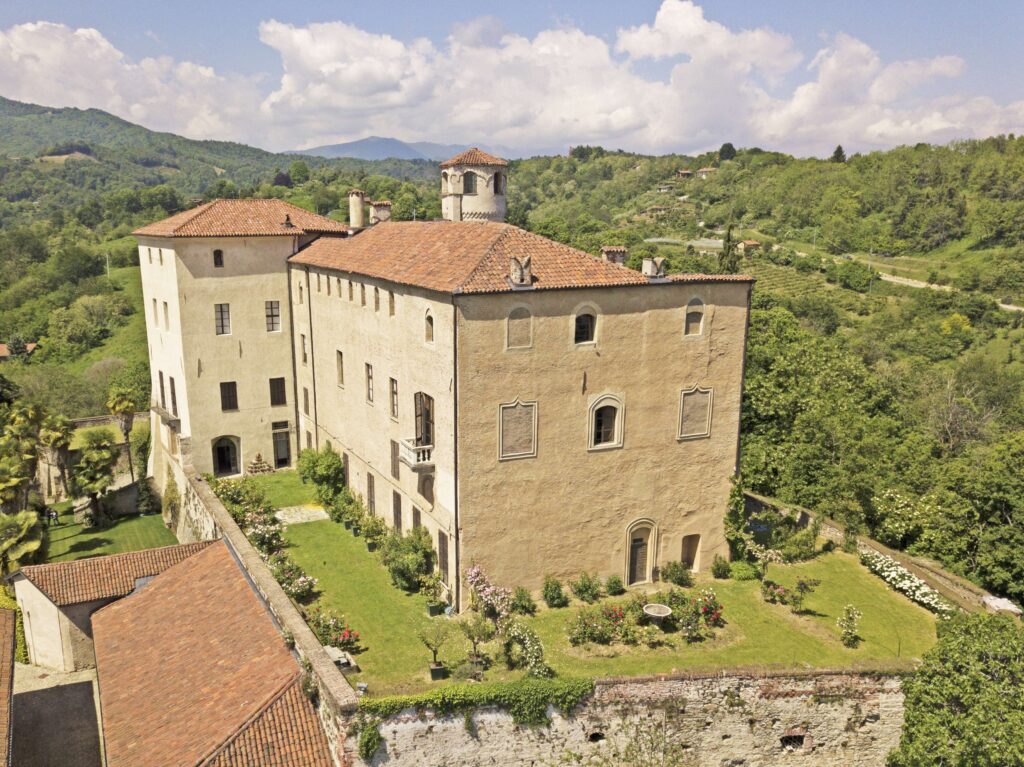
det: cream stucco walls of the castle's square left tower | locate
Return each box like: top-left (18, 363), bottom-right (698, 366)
top-left (139, 237), bottom-right (311, 482)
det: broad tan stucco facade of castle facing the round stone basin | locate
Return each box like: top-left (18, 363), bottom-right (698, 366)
top-left (458, 283), bottom-right (749, 589)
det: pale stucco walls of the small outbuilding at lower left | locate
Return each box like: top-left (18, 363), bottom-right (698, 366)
top-left (12, 574), bottom-right (114, 671)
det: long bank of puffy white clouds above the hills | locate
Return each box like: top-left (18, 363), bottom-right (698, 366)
top-left (0, 5), bottom-right (1024, 155)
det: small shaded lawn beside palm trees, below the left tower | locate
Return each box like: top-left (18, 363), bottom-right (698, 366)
top-left (47, 511), bottom-right (177, 562)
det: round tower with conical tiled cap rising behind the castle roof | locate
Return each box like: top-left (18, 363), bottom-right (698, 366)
top-left (441, 146), bottom-right (508, 221)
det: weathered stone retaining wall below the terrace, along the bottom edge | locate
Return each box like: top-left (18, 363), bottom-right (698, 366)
top-left (347, 672), bottom-right (903, 767)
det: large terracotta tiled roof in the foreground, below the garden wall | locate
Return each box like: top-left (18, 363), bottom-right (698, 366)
top-left (92, 541), bottom-right (332, 767)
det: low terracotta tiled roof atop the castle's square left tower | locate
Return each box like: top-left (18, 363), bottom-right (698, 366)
top-left (132, 200), bottom-right (348, 237)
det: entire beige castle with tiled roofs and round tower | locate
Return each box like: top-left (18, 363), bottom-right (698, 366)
top-left (136, 150), bottom-right (752, 604)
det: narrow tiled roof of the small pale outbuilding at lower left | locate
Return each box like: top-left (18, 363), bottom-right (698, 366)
top-left (22, 541), bottom-right (210, 605)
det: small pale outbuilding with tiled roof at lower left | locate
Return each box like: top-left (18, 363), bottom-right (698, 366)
top-left (10, 541), bottom-right (210, 671)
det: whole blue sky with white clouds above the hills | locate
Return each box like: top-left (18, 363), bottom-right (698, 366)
top-left (0, 0), bottom-right (1024, 154)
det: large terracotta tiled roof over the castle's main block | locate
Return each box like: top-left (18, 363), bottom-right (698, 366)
top-left (291, 221), bottom-right (750, 294)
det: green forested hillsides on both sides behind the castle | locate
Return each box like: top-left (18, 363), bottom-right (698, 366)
top-left (0, 102), bottom-right (1024, 601)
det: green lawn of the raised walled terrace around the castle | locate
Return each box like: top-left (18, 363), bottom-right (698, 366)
top-left (286, 521), bottom-right (935, 694)
